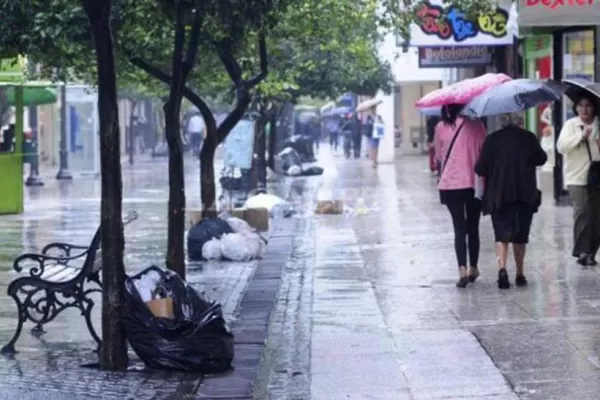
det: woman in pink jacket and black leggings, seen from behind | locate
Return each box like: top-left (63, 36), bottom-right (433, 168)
top-left (434, 104), bottom-right (486, 288)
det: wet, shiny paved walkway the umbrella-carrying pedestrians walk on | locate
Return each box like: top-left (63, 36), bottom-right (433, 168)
top-left (255, 147), bottom-right (600, 400)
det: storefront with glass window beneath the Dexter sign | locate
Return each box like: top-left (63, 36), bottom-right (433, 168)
top-left (519, 0), bottom-right (600, 202)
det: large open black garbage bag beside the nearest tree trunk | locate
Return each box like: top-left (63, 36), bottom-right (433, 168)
top-left (125, 266), bottom-right (234, 373)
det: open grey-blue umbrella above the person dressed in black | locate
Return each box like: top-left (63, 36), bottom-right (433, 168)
top-left (461, 79), bottom-right (565, 117)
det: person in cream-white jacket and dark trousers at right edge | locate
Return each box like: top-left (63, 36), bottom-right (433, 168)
top-left (556, 94), bottom-right (600, 266)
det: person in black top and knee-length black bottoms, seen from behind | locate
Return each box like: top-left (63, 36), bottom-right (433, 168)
top-left (475, 116), bottom-right (548, 289)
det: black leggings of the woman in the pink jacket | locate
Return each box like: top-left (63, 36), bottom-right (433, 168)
top-left (444, 189), bottom-right (481, 267)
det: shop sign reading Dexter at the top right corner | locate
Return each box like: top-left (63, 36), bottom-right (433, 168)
top-left (519, 0), bottom-right (600, 27)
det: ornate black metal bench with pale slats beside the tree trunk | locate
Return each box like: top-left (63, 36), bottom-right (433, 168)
top-left (1, 211), bottom-right (138, 354)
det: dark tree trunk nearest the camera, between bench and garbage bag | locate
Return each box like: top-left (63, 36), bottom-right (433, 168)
top-left (83, 0), bottom-right (128, 371)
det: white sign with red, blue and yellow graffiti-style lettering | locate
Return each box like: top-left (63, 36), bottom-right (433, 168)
top-left (410, 0), bottom-right (513, 47)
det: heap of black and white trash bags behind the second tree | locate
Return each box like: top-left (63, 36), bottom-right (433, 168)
top-left (187, 213), bottom-right (267, 261)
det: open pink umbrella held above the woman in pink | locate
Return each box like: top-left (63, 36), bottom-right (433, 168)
top-left (415, 73), bottom-right (512, 108)
